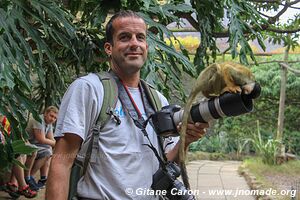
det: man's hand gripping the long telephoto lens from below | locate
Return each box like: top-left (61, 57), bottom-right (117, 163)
top-left (177, 122), bottom-right (209, 148)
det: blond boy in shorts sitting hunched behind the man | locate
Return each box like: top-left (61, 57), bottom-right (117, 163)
top-left (25, 106), bottom-right (58, 190)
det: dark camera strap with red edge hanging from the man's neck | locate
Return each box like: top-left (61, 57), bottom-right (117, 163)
top-left (113, 74), bottom-right (167, 168)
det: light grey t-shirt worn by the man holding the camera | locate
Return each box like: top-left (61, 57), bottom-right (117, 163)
top-left (55, 74), bottom-right (178, 200)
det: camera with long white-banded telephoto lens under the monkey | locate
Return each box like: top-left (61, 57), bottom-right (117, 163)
top-left (152, 83), bottom-right (261, 136)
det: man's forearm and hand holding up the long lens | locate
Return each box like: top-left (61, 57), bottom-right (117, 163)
top-left (166, 122), bottom-right (209, 162)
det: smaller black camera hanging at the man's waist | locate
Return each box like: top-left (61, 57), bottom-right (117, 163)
top-left (151, 162), bottom-right (196, 200)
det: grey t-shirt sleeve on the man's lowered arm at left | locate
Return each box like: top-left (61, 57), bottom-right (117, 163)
top-left (55, 74), bottom-right (103, 140)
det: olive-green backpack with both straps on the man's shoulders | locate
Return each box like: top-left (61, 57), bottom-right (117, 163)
top-left (68, 72), bottom-right (162, 200)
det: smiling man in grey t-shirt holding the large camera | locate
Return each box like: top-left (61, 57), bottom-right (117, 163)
top-left (46, 11), bottom-right (208, 200)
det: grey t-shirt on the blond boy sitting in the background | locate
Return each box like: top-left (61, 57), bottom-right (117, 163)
top-left (26, 114), bottom-right (53, 147)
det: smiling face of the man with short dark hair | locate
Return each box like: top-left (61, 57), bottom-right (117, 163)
top-left (104, 17), bottom-right (148, 74)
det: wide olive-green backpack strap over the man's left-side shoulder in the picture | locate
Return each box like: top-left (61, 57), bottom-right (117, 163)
top-left (83, 72), bottom-right (118, 175)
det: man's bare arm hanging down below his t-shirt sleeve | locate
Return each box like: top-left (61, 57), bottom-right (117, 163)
top-left (46, 133), bottom-right (82, 200)
